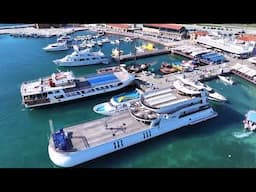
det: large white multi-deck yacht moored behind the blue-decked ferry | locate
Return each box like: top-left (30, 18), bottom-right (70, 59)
top-left (53, 45), bottom-right (110, 66)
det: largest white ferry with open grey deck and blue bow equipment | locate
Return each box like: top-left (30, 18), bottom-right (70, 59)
top-left (48, 88), bottom-right (217, 167)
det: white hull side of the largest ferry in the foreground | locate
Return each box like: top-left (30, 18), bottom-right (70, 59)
top-left (48, 108), bottom-right (217, 167)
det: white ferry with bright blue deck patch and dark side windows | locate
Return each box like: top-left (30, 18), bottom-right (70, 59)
top-left (20, 68), bottom-right (135, 108)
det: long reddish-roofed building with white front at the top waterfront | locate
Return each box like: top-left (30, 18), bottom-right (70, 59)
top-left (143, 24), bottom-right (188, 40)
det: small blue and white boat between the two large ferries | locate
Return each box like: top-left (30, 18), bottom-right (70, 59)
top-left (93, 89), bottom-right (142, 115)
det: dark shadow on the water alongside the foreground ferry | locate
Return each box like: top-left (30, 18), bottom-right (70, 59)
top-left (77, 103), bottom-right (243, 168)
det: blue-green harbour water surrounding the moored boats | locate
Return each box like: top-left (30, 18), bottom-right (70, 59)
top-left (0, 29), bottom-right (256, 168)
